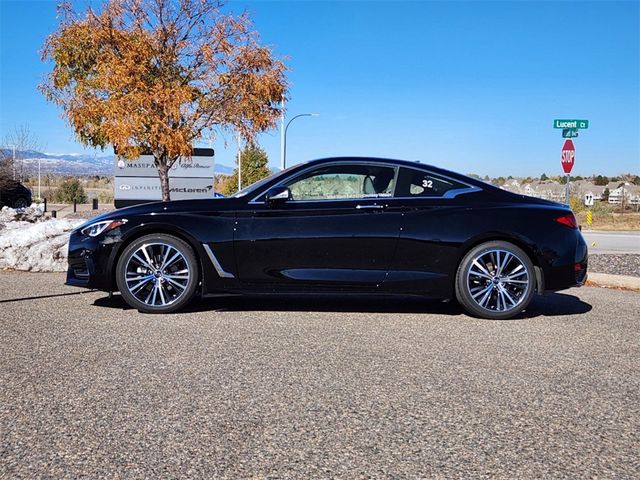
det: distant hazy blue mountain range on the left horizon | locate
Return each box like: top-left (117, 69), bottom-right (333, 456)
top-left (0, 149), bottom-right (233, 175)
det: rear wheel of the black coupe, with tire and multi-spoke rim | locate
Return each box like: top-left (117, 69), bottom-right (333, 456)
top-left (455, 240), bottom-right (536, 320)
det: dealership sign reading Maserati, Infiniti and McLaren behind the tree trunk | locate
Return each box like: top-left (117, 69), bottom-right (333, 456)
top-left (114, 148), bottom-right (213, 208)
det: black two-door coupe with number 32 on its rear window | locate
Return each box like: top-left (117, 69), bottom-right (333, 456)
top-left (67, 158), bottom-right (587, 319)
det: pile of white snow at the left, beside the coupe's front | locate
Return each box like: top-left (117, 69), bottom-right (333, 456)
top-left (0, 207), bottom-right (84, 272)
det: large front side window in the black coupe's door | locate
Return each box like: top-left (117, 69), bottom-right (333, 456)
top-left (287, 165), bottom-right (395, 201)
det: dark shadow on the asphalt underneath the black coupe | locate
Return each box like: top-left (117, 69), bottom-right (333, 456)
top-left (94, 293), bottom-right (592, 320)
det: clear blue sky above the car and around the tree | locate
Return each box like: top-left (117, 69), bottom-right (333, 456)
top-left (0, 0), bottom-right (640, 177)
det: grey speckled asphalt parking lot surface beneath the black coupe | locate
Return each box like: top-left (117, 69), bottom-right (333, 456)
top-left (0, 272), bottom-right (640, 479)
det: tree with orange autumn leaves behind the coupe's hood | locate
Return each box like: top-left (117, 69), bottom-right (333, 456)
top-left (40, 0), bottom-right (287, 201)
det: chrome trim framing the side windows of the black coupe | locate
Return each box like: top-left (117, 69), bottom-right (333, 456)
top-left (248, 161), bottom-right (482, 205)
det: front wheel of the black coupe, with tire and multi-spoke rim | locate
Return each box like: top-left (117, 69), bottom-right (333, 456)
top-left (116, 234), bottom-right (199, 313)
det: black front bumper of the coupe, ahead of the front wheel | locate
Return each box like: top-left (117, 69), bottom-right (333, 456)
top-left (65, 229), bottom-right (122, 291)
